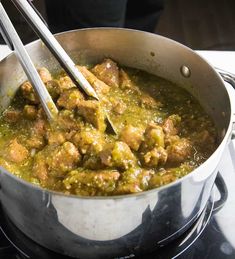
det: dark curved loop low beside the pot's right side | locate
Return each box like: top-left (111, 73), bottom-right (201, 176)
top-left (213, 172), bottom-right (228, 214)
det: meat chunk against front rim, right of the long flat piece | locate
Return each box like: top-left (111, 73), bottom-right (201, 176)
top-left (115, 168), bottom-right (154, 194)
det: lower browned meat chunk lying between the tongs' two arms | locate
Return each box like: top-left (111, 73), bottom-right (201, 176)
top-left (57, 88), bottom-right (84, 110)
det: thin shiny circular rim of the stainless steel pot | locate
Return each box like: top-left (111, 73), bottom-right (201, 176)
top-left (0, 27), bottom-right (234, 200)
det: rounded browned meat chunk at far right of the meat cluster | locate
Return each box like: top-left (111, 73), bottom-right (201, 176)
top-left (167, 138), bottom-right (192, 163)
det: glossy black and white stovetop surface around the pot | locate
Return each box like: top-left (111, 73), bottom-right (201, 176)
top-left (0, 46), bottom-right (235, 259)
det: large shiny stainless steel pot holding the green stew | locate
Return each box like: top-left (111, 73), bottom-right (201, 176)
top-left (0, 28), bottom-right (234, 258)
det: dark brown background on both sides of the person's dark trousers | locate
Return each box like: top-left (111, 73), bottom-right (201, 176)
top-left (2, 0), bottom-right (235, 50)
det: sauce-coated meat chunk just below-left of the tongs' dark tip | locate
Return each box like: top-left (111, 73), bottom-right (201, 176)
top-left (72, 129), bottom-right (104, 154)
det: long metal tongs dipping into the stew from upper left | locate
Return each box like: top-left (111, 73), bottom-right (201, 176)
top-left (0, 0), bottom-right (116, 133)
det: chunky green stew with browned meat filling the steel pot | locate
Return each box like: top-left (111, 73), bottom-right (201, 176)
top-left (0, 59), bottom-right (216, 196)
